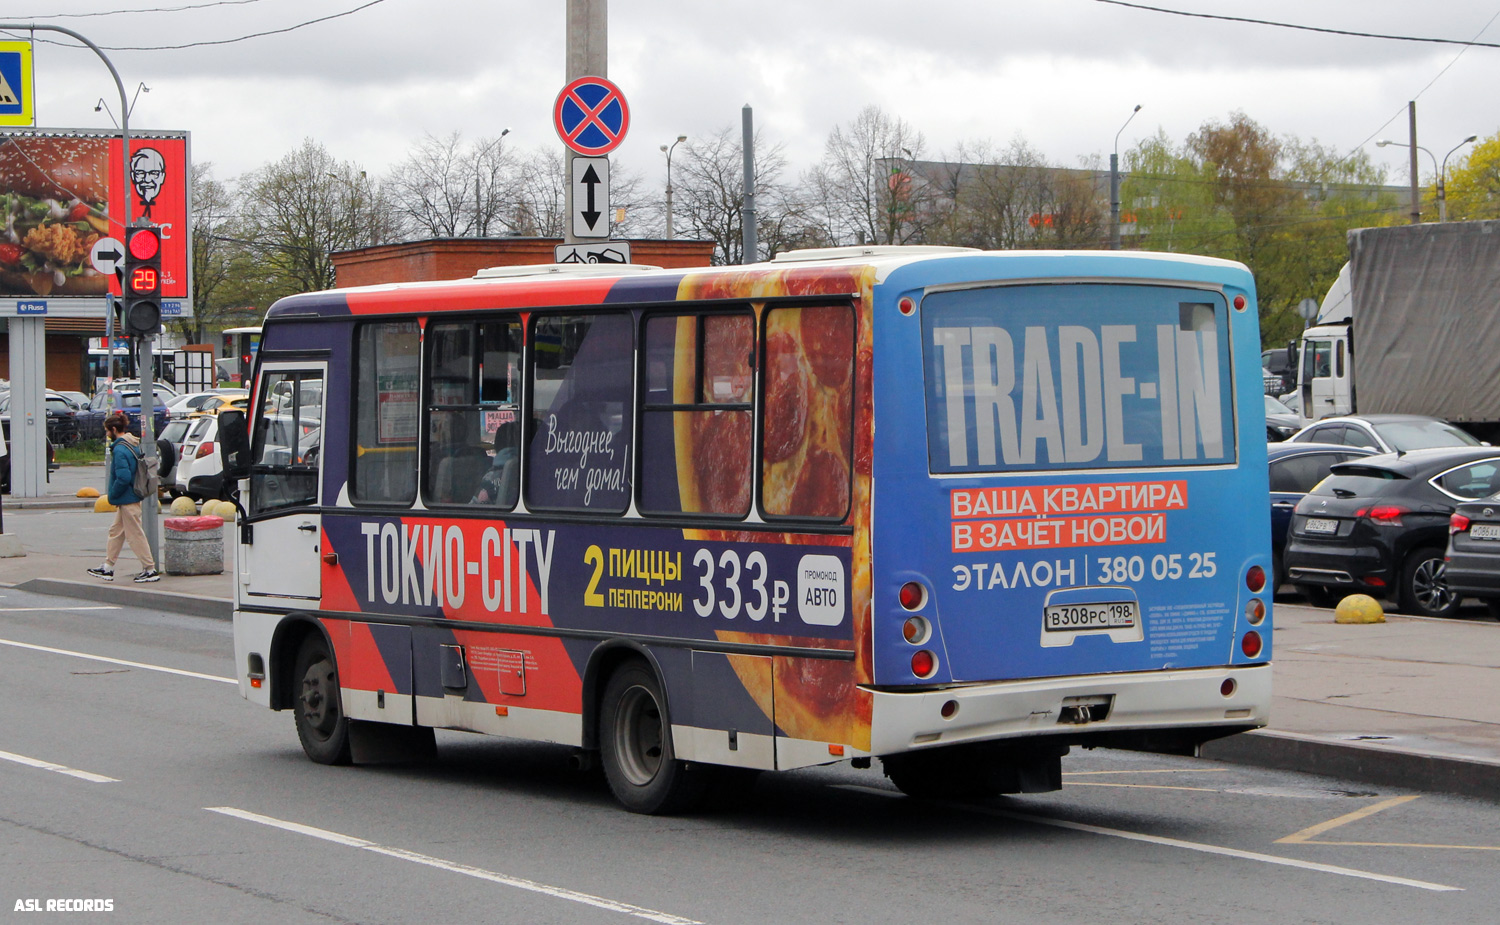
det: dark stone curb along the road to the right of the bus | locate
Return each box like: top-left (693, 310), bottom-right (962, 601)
top-left (1199, 730), bottom-right (1500, 802)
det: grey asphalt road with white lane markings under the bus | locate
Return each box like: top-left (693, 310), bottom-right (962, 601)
top-left (0, 591), bottom-right (1500, 925)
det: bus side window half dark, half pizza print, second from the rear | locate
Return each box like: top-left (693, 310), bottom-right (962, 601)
top-left (639, 312), bottom-right (755, 517)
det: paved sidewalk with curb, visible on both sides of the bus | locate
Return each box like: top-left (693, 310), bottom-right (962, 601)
top-left (0, 466), bottom-right (1500, 799)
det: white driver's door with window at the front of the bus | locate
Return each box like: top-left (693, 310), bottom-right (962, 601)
top-left (240, 363), bottom-right (326, 600)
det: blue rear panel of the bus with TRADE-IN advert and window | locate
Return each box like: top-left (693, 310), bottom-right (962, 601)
top-left (872, 255), bottom-right (1271, 685)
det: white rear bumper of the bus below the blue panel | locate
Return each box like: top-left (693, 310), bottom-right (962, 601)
top-left (870, 664), bottom-right (1271, 754)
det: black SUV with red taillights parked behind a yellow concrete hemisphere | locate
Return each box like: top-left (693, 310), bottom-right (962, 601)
top-left (1284, 447), bottom-right (1500, 616)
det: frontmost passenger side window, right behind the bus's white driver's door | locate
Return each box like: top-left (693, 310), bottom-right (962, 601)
top-left (350, 321), bottom-right (422, 505)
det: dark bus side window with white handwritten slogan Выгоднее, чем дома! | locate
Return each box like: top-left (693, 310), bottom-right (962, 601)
top-left (525, 312), bottom-right (636, 514)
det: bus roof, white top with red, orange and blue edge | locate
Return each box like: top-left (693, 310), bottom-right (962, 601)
top-left (261, 246), bottom-right (1248, 320)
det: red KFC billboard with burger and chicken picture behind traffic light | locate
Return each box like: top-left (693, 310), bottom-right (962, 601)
top-left (0, 130), bottom-right (192, 316)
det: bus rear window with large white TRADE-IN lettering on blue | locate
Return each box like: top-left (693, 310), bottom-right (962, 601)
top-left (923, 283), bottom-right (1235, 472)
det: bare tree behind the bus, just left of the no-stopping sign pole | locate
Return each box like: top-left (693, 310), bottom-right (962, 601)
top-left (386, 132), bottom-right (519, 238)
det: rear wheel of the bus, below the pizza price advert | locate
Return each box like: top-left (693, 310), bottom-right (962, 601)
top-left (599, 661), bottom-right (713, 816)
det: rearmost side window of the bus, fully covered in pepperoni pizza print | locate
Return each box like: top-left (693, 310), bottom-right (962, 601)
top-left (761, 304), bottom-right (855, 519)
